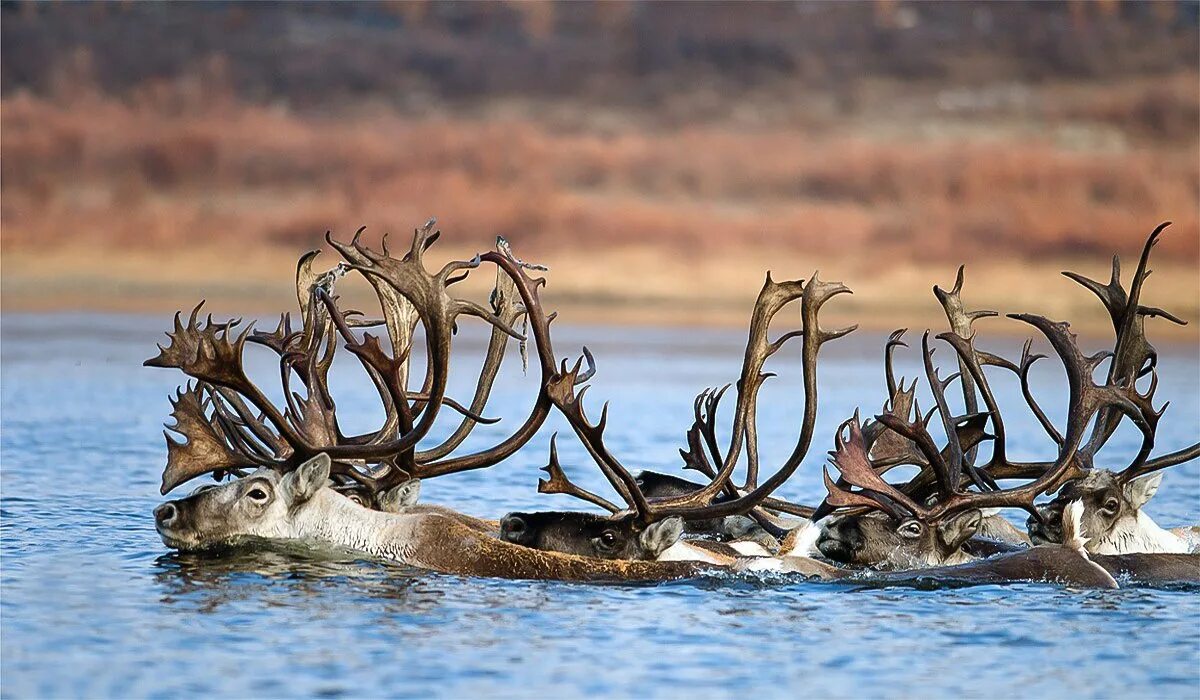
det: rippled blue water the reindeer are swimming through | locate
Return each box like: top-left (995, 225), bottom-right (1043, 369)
top-left (0, 315), bottom-right (1200, 698)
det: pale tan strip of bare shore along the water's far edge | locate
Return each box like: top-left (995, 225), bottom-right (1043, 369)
top-left (0, 240), bottom-right (1200, 342)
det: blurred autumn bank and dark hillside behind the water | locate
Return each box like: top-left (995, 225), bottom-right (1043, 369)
top-left (0, 0), bottom-right (1200, 339)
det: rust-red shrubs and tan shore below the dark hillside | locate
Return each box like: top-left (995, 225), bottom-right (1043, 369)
top-left (0, 1), bottom-right (1200, 336)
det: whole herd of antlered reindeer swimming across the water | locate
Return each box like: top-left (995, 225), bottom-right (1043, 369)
top-left (145, 221), bottom-right (1200, 587)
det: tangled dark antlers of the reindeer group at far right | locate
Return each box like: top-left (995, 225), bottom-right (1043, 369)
top-left (815, 225), bottom-right (1200, 521)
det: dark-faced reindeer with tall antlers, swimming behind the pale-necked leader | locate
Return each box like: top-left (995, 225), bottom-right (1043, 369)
top-left (500, 268), bottom-right (853, 563)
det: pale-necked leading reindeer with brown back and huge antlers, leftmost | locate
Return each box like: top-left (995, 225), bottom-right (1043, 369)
top-left (146, 221), bottom-right (697, 580)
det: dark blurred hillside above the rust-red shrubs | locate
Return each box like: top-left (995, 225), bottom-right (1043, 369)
top-left (0, 0), bottom-right (1200, 108)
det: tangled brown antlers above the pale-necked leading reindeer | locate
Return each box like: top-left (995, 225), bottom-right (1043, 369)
top-left (145, 220), bottom-right (554, 493)
